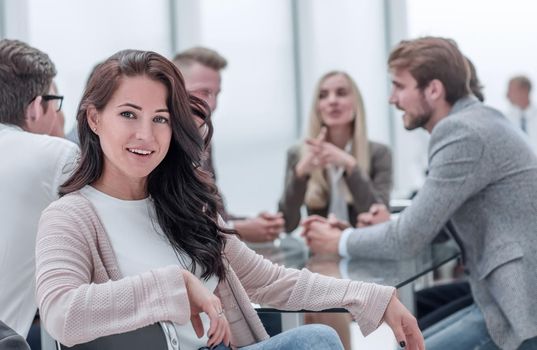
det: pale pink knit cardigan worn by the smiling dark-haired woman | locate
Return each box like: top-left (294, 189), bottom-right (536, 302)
top-left (36, 192), bottom-right (394, 347)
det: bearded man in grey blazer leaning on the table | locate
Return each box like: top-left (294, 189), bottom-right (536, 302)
top-left (304, 37), bottom-right (537, 350)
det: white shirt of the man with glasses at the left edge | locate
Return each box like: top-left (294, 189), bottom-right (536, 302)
top-left (0, 123), bottom-right (78, 337)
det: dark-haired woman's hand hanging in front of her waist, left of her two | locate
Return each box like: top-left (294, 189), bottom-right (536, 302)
top-left (183, 270), bottom-right (231, 347)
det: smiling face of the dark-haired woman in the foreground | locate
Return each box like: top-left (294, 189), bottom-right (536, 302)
top-left (88, 75), bottom-right (172, 183)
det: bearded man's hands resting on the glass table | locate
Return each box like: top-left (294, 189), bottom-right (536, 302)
top-left (301, 204), bottom-right (390, 254)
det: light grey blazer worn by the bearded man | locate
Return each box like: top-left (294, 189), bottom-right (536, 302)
top-left (347, 97), bottom-right (537, 350)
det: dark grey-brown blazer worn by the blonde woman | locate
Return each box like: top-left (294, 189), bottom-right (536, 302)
top-left (278, 141), bottom-right (392, 232)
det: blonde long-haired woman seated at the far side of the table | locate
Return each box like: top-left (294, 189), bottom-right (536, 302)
top-left (279, 71), bottom-right (392, 232)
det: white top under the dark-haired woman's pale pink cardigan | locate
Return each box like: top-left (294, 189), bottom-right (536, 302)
top-left (80, 186), bottom-right (218, 350)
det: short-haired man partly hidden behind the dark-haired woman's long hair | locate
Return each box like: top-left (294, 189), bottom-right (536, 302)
top-left (173, 47), bottom-right (284, 242)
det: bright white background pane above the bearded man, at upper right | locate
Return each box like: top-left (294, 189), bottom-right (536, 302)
top-left (407, 0), bottom-right (537, 117)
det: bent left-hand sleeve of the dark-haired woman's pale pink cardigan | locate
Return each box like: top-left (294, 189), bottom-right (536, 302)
top-left (36, 197), bottom-right (190, 346)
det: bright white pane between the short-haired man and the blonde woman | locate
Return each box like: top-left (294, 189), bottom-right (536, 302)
top-left (185, 0), bottom-right (295, 215)
